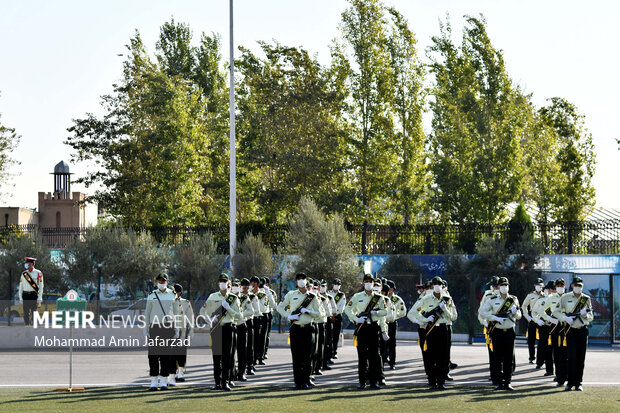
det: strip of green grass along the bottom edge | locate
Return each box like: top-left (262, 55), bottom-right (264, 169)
top-left (0, 386), bottom-right (620, 413)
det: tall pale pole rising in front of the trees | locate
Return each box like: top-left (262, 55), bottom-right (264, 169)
top-left (228, 0), bottom-right (237, 277)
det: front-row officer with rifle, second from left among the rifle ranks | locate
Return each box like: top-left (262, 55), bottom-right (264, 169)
top-left (276, 272), bottom-right (320, 390)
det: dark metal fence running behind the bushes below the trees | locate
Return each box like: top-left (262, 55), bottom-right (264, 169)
top-left (0, 220), bottom-right (620, 254)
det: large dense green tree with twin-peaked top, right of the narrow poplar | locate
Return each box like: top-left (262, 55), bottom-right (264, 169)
top-left (429, 17), bottom-right (527, 229)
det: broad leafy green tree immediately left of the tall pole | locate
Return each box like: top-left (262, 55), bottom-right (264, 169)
top-left (66, 20), bottom-right (227, 225)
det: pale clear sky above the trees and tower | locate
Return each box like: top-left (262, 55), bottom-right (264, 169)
top-left (0, 0), bottom-right (620, 224)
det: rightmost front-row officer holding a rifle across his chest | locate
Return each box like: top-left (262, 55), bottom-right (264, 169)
top-left (553, 277), bottom-right (594, 391)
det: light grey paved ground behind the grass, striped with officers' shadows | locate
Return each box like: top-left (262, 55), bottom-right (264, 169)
top-left (0, 334), bottom-right (620, 387)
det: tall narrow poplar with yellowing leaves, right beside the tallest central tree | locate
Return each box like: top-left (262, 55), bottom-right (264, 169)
top-left (387, 8), bottom-right (429, 225)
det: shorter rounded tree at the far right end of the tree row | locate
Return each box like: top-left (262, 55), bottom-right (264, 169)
top-left (539, 97), bottom-right (596, 222)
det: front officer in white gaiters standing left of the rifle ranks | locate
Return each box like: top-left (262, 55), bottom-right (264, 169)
top-left (144, 273), bottom-right (179, 391)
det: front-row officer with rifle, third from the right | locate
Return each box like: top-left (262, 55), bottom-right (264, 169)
top-left (414, 277), bottom-right (452, 390)
